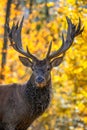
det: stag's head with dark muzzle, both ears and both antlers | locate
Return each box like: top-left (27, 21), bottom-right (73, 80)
top-left (7, 17), bottom-right (83, 87)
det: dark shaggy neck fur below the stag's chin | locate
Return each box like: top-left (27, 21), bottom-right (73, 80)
top-left (25, 75), bottom-right (51, 117)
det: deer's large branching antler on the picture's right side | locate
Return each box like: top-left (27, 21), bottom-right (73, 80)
top-left (47, 17), bottom-right (84, 59)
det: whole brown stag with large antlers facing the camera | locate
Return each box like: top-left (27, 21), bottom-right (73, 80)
top-left (0, 17), bottom-right (83, 130)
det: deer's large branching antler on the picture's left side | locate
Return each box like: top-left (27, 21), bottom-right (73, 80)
top-left (7, 17), bottom-right (36, 60)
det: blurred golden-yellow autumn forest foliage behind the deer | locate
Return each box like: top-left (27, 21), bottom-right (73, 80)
top-left (0, 0), bottom-right (87, 130)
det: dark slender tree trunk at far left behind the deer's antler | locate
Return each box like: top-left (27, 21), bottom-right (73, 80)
top-left (0, 0), bottom-right (12, 79)
